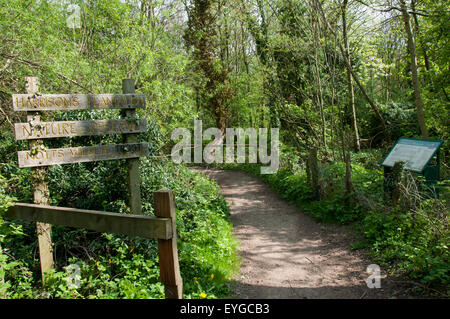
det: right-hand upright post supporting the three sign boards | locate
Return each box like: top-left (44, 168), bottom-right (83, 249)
top-left (122, 79), bottom-right (142, 215)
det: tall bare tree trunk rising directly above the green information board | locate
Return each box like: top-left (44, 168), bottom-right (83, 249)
top-left (399, 0), bottom-right (428, 138)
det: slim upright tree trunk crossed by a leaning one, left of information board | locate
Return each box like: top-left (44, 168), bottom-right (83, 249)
top-left (342, 0), bottom-right (361, 152)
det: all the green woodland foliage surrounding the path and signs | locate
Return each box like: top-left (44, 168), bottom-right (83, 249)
top-left (0, 0), bottom-right (450, 298)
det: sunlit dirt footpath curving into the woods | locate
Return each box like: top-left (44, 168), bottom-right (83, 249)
top-left (195, 168), bottom-right (411, 299)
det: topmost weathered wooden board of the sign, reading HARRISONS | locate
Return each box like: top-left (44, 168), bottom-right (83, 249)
top-left (13, 94), bottom-right (145, 111)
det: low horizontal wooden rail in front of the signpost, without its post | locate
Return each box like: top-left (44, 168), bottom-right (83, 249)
top-left (3, 203), bottom-right (173, 240)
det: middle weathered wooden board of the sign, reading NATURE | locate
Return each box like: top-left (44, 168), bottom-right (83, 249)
top-left (14, 120), bottom-right (147, 140)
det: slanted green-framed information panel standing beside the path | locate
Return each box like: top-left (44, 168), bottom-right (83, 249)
top-left (381, 137), bottom-right (444, 173)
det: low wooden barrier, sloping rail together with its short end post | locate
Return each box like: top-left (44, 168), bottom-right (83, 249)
top-left (3, 190), bottom-right (183, 299)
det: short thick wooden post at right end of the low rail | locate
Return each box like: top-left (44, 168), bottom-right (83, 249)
top-left (154, 190), bottom-right (183, 299)
